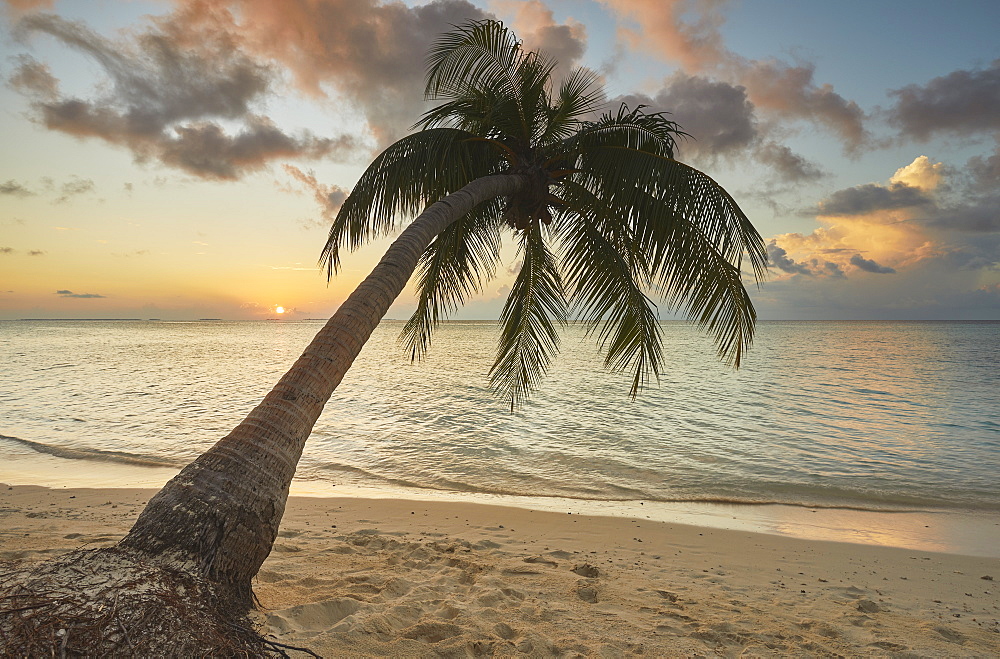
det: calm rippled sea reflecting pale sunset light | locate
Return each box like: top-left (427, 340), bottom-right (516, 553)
top-left (0, 321), bottom-right (1000, 512)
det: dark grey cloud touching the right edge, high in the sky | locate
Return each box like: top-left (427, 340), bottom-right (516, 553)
top-left (888, 59), bottom-right (1000, 140)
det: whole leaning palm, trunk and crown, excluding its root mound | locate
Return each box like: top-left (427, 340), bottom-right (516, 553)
top-left (3, 21), bottom-right (765, 652)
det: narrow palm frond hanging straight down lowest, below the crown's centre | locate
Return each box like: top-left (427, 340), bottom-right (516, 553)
top-left (490, 224), bottom-right (566, 411)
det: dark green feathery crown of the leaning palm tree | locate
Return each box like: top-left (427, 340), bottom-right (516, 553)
top-left (321, 21), bottom-right (766, 408)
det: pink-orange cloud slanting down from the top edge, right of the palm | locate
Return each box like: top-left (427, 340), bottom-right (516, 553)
top-left (601, 0), bottom-right (870, 153)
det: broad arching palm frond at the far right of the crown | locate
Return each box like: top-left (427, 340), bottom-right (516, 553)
top-left (560, 146), bottom-right (766, 366)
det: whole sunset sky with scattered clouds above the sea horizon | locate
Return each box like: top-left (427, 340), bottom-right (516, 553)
top-left (0, 0), bottom-right (1000, 320)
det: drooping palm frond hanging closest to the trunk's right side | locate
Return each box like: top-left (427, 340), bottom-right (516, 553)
top-left (400, 200), bottom-right (500, 360)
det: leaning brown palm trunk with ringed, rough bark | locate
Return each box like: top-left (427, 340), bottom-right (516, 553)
top-left (119, 174), bottom-right (528, 606)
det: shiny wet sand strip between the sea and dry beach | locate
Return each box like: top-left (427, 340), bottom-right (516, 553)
top-left (0, 454), bottom-right (1000, 558)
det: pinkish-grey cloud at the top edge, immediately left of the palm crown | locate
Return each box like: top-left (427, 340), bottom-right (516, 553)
top-left (214, 0), bottom-right (488, 146)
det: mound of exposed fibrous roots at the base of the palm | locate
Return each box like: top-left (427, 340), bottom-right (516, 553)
top-left (0, 548), bottom-right (315, 657)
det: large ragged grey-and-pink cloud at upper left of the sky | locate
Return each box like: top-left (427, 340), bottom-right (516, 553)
top-left (11, 10), bottom-right (355, 180)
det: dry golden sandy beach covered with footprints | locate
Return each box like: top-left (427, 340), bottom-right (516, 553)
top-left (0, 485), bottom-right (1000, 657)
